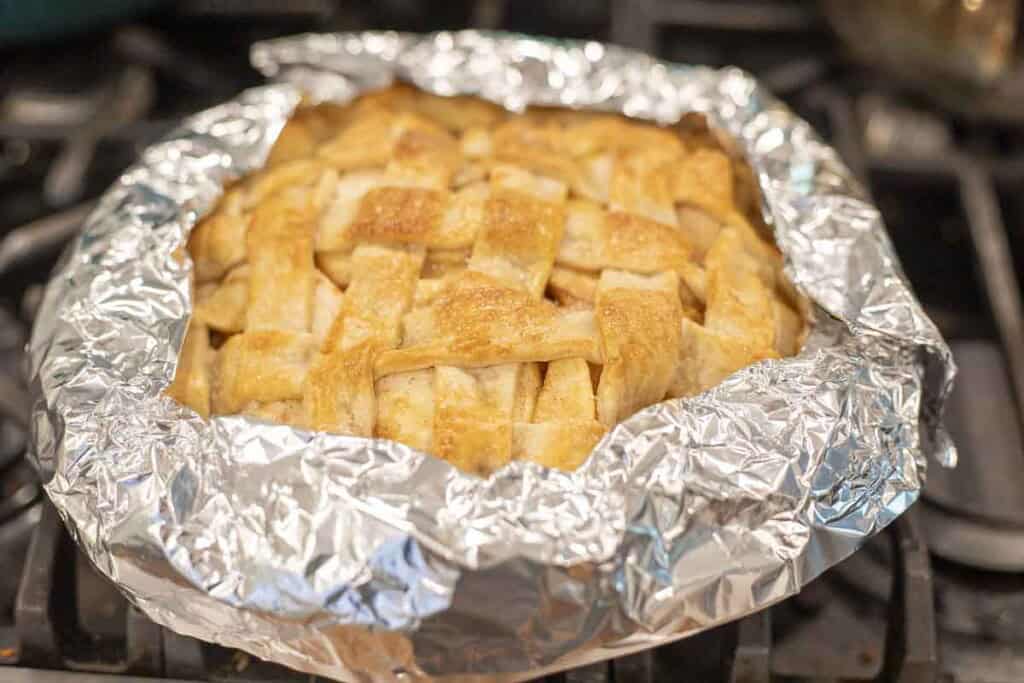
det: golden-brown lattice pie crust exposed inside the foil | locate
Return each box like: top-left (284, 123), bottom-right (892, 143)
top-left (168, 86), bottom-right (805, 474)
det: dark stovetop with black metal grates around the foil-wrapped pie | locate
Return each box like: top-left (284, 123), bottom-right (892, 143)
top-left (0, 0), bottom-right (1024, 683)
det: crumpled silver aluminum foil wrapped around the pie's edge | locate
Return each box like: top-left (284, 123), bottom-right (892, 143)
top-left (30, 32), bottom-right (955, 681)
